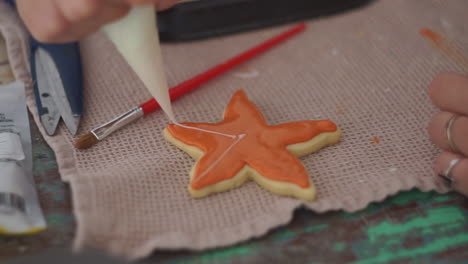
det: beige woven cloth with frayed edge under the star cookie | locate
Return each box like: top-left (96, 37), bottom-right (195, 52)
top-left (0, 0), bottom-right (468, 259)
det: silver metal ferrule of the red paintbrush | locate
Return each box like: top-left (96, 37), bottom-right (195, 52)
top-left (91, 107), bottom-right (145, 140)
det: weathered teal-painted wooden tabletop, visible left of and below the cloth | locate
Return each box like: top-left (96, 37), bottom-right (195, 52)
top-left (0, 119), bottom-right (468, 264)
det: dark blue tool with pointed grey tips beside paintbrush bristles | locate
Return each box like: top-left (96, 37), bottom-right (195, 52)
top-left (7, 0), bottom-right (83, 135)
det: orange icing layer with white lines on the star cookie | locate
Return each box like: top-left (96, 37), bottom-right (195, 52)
top-left (168, 90), bottom-right (337, 189)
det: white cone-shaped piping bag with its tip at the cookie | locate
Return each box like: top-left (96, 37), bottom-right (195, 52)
top-left (101, 6), bottom-right (177, 123)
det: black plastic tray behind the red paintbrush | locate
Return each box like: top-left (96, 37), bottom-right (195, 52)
top-left (158, 0), bottom-right (373, 42)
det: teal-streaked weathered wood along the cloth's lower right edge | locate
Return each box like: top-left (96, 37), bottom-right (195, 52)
top-left (153, 191), bottom-right (468, 264)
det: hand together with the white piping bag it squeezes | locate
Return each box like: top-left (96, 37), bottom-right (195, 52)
top-left (12, 0), bottom-right (183, 126)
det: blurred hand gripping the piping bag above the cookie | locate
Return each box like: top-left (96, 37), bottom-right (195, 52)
top-left (12, 0), bottom-right (178, 43)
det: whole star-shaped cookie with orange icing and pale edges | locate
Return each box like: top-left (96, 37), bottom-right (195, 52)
top-left (164, 90), bottom-right (341, 201)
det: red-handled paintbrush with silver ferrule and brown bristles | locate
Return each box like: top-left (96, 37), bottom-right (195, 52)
top-left (75, 23), bottom-right (306, 149)
